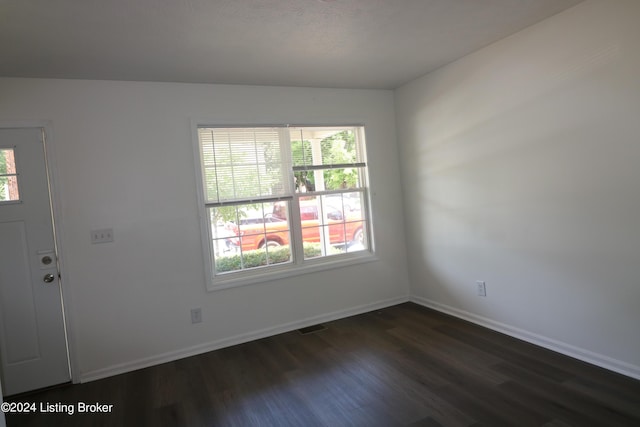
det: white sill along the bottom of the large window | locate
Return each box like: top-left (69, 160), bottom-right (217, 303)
top-left (207, 251), bottom-right (378, 291)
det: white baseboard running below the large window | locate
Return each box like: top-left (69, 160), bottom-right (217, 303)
top-left (80, 295), bottom-right (410, 383)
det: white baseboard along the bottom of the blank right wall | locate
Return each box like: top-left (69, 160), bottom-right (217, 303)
top-left (410, 295), bottom-right (640, 379)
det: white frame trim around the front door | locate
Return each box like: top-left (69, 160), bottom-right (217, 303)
top-left (0, 120), bottom-right (80, 384)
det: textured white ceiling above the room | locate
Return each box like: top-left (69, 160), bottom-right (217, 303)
top-left (0, 0), bottom-right (582, 89)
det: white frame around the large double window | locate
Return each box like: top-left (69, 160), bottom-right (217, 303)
top-left (192, 120), bottom-right (378, 291)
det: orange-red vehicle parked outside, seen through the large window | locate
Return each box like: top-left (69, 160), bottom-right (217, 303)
top-left (227, 200), bottom-right (364, 251)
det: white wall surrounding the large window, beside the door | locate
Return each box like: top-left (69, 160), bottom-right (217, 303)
top-left (0, 79), bottom-right (409, 379)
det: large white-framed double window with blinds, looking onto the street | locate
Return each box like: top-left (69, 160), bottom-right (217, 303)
top-left (197, 126), bottom-right (372, 288)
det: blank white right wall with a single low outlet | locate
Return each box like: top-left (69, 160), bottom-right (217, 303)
top-left (396, 0), bottom-right (640, 377)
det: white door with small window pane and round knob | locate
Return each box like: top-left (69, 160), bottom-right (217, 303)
top-left (0, 128), bottom-right (71, 396)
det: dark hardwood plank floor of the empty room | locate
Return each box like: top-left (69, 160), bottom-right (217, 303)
top-left (7, 303), bottom-right (640, 427)
